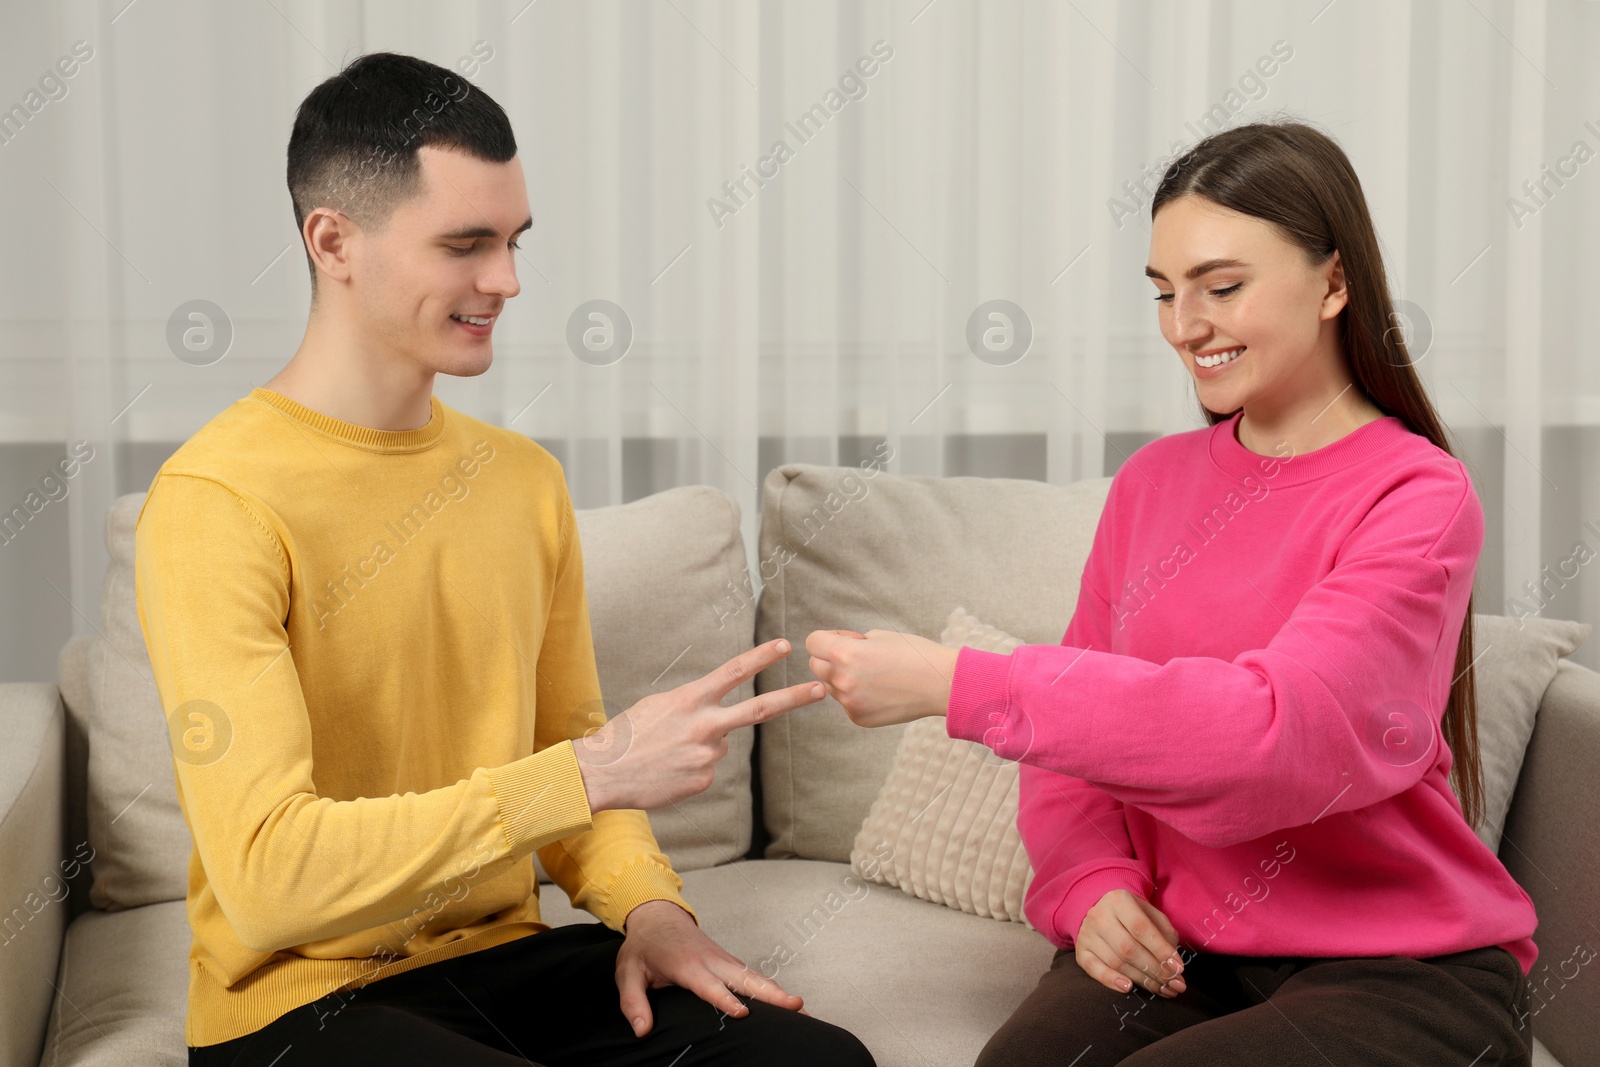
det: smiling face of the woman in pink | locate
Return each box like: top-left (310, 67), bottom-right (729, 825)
top-left (1144, 195), bottom-right (1347, 413)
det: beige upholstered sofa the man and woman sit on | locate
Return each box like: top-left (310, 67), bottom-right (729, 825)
top-left (0, 464), bottom-right (1600, 1067)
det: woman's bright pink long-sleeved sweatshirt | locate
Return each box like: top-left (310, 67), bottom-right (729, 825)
top-left (946, 414), bottom-right (1538, 973)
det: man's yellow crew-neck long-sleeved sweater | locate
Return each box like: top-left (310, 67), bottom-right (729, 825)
top-left (136, 389), bottom-right (694, 1046)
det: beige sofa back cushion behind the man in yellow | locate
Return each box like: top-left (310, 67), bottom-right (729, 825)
top-left (68, 486), bottom-right (755, 910)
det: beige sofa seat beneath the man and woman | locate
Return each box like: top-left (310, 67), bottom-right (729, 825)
top-left (40, 883), bottom-right (1562, 1067)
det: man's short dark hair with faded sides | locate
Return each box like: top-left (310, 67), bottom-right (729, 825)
top-left (288, 51), bottom-right (517, 293)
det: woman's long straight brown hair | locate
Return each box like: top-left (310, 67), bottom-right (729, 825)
top-left (1150, 122), bottom-right (1483, 827)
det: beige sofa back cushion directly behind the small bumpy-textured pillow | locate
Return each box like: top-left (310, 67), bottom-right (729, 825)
top-left (755, 464), bottom-right (1110, 862)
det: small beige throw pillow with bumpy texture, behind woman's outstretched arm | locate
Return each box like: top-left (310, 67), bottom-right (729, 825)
top-left (850, 608), bottom-right (1034, 926)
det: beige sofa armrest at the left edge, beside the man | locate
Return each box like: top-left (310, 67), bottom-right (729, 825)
top-left (0, 681), bottom-right (67, 1067)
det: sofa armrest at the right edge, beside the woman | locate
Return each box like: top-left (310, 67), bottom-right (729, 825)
top-left (1499, 659), bottom-right (1600, 1064)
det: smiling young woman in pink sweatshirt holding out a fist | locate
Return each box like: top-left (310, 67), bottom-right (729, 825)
top-left (806, 123), bottom-right (1538, 1067)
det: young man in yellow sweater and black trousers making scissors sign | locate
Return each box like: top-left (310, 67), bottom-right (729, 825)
top-left (136, 54), bottom-right (872, 1067)
